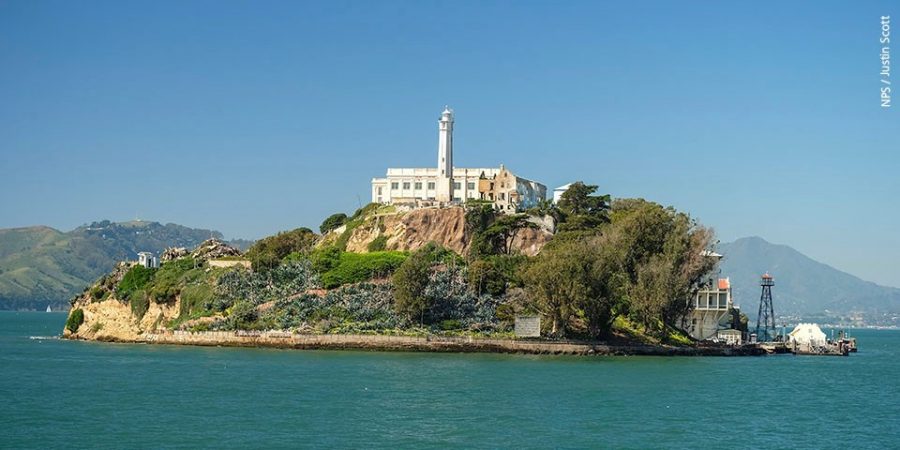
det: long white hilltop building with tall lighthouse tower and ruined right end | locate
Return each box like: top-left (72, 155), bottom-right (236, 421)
top-left (372, 107), bottom-right (547, 212)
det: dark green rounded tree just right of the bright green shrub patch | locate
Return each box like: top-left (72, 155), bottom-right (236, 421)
top-left (392, 250), bottom-right (432, 324)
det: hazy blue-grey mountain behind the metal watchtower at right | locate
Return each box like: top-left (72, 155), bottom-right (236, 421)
top-left (718, 237), bottom-right (900, 319)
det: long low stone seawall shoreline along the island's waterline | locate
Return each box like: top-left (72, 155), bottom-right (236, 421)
top-left (63, 331), bottom-right (765, 356)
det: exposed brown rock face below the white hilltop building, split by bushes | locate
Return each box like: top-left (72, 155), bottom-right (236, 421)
top-left (347, 207), bottom-right (553, 256)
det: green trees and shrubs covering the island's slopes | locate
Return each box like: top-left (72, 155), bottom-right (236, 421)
top-left (67, 183), bottom-right (714, 342)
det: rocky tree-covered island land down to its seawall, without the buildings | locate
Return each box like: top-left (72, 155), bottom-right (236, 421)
top-left (63, 182), bottom-right (760, 355)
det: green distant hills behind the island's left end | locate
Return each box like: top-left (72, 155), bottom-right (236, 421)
top-left (0, 220), bottom-right (250, 310)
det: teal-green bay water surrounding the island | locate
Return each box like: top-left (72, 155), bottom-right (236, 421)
top-left (0, 312), bottom-right (900, 449)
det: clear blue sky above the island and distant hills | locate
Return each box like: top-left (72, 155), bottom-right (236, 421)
top-left (0, 0), bottom-right (900, 286)
